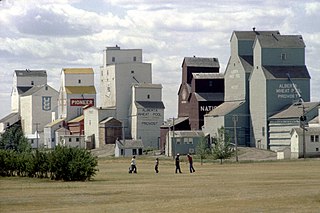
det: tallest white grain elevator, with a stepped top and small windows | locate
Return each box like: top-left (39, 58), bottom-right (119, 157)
top-left (100, 46), bottom-right (152, 138)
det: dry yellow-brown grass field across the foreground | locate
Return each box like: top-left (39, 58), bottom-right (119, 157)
top-left (0, 157), bottom-right (320, 213)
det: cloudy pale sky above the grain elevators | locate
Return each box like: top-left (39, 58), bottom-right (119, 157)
top-left (0, 0), bottom-right (320, 119)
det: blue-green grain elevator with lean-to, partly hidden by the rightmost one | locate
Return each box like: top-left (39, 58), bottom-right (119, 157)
top-left (203, 30), bottom-right (278, 146)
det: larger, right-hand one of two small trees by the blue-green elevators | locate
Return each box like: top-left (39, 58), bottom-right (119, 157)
top-left (212, 127), bottom-right (233, 164)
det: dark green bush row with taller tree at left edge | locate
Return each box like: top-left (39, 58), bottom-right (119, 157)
top-left (0, 125), bottom-right (98, 181)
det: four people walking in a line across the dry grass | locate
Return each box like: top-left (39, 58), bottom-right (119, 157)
top-left (129, 153), bottom-right (196, 173)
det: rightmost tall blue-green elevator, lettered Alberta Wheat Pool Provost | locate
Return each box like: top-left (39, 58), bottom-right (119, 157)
top-left (249, 33), bottom-right (310, 149)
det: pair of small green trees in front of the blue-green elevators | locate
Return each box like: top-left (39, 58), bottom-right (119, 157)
top-left (196, 127), bottom-right (234, 164)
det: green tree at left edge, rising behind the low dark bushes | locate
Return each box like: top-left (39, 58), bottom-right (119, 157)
top-left (0, 123), bottom-right (31, 153)
